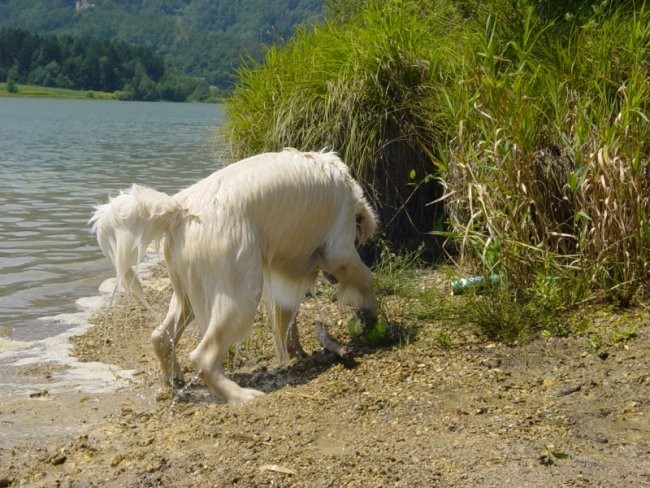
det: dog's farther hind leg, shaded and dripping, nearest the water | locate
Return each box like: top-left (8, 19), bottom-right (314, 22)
top-left (151, 293), bottom-right (194, 386)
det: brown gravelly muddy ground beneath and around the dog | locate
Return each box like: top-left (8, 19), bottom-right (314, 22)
top-left (0, 264), bottom-right (650, 487)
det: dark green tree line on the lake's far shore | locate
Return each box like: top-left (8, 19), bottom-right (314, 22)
top-left (0, 28), bottom-right (209, 101)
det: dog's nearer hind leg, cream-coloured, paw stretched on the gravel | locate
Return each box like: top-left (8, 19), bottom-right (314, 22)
top-left (190, 294), bottom-right (264, 404)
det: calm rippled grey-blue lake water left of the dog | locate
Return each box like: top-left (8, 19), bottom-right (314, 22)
top-left (0, 98), bottom-right (222, 340)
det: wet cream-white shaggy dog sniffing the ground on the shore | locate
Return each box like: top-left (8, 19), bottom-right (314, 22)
top-left (91, 149), bottom-right (377, 403)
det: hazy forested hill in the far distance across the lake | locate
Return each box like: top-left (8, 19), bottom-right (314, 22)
top-left (0, 0), bottom-right (324, 90)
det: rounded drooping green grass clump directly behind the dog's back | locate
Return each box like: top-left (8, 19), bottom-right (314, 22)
top-left (225, 1), bottom-right (468, 252)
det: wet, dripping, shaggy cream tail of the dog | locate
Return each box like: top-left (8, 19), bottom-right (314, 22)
top-left (90, 185), bottom-right (186, 308)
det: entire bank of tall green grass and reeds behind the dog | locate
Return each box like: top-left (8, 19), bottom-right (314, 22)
top-left (225, 0), bottom-right (650, 340)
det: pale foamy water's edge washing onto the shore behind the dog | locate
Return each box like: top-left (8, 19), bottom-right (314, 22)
top-left (0, 250), bottom-right (165, 450)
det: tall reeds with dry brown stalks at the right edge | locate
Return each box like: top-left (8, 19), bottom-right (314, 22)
top-left (440, 6), bottom-right (650, 336)
